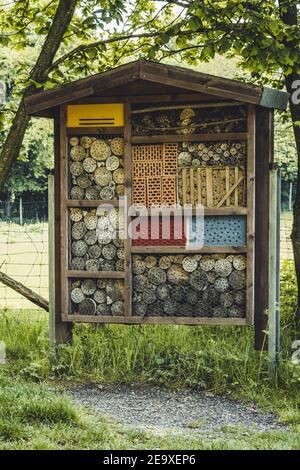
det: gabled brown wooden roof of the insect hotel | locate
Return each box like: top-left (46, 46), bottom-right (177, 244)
top-left (25, 60), bottom-right (289, 117)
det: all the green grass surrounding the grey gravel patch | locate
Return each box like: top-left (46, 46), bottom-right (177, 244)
top-left (0, 263), bottom-right (300, 449)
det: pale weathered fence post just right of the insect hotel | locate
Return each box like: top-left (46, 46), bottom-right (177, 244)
top-left (268, 168), bottom-right (281, 378)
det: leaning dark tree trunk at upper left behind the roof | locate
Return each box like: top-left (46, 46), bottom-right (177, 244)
top-left (0, 0), bottom-right (77, 190)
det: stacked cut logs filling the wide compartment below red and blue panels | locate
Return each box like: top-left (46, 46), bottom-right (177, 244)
top-left (132, 254), bottom-right (246, 318)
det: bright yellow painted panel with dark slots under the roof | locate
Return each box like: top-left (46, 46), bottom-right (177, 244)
top-left (67, 103), bottom-right (124, 127)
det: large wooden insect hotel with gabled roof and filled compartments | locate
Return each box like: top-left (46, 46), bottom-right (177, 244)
top-left (25, 61), bottom-right (287, 344)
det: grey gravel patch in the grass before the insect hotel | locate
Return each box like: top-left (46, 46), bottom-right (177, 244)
top-left (68, 385), bottom-right (286, 437)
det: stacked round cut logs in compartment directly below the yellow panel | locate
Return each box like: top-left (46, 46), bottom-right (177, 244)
top-left (69, 136), bottom-right (124, 200)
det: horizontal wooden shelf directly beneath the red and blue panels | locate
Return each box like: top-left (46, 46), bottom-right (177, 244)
top-left (131, 245), bottom-right (247, 255)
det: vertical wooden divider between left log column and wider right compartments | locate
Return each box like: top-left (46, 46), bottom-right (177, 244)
top-left (124, 103), bottom-right (132, 316)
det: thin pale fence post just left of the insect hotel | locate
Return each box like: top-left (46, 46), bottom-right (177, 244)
top-left (48, 175), bottom-right (55, 351)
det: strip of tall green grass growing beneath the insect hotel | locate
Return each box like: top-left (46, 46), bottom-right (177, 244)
top-left (0, 263), bottom-right (300, 416)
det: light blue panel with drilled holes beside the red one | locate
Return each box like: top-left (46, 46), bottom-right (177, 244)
top-left (189, 216), bottom-right (247, 247)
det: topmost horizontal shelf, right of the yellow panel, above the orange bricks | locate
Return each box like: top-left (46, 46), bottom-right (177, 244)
top-left (131, 132), bottom-right (248, 144)
